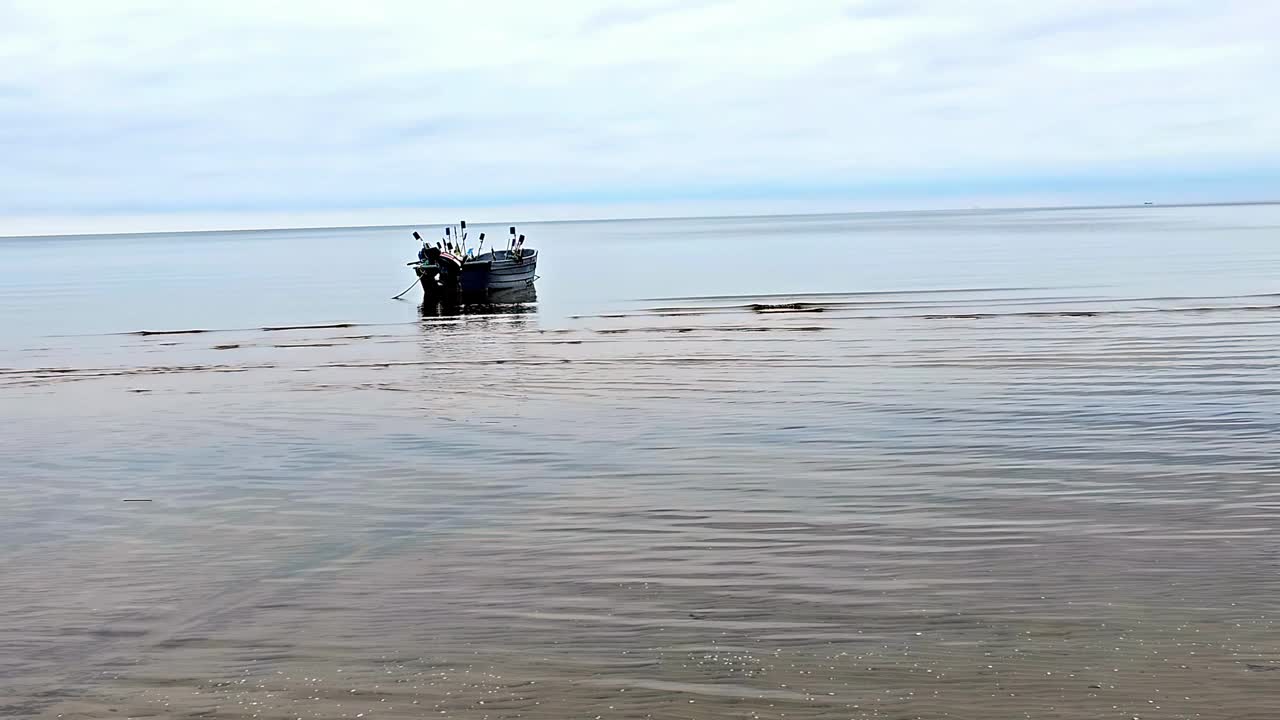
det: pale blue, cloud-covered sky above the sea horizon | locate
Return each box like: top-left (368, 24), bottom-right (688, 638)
top-left (0, 0), bottom-right (1280, 234)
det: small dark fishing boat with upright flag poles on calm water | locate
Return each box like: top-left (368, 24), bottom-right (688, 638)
top-left (401, 220), bottom-right (538, 301)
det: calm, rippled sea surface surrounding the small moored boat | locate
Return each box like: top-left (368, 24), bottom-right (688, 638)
top-left (0, 206), bottom-right (1280, 720)
